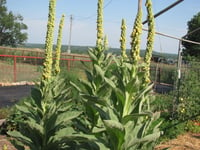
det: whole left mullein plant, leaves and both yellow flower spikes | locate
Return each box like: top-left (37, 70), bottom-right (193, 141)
top-left (8, 0), bottom-right (93, 150)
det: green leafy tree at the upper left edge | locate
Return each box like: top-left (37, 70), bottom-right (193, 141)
top-left (0, 0), bottom-right (27, 47)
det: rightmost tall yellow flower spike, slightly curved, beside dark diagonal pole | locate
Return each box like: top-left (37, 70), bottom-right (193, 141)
top-left (144, 0), bottom-right (155, 84)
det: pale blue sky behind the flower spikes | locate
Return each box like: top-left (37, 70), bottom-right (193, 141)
top-left (7, 0), bottom-right (200, 53)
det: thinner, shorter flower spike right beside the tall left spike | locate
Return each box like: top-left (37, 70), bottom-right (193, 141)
top-left (54, 15), bottom-right (65, 75)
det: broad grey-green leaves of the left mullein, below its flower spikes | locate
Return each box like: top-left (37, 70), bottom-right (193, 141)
top-left (8, 77), bottom-right (81, 150)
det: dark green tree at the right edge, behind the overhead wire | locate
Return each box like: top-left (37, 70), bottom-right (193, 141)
top-left (182, 12), bottom-right (200, 59)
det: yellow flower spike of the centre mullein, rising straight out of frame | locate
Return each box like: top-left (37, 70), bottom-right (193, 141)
top-left (96, 0), bottom-right (104, 50)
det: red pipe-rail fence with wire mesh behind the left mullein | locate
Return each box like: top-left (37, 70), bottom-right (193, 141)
top-left (0, 55), bottom-right (90, 82)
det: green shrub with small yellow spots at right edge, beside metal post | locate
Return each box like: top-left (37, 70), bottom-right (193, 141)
top-left (177, 62), bottom-right (200, 120)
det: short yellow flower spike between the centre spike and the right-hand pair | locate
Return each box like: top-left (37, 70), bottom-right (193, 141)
top-left (120, 19), bottom-right (127, 60)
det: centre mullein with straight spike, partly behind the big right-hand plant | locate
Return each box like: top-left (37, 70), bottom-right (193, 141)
top-left (72, 0), bottom-right (115, 133)
